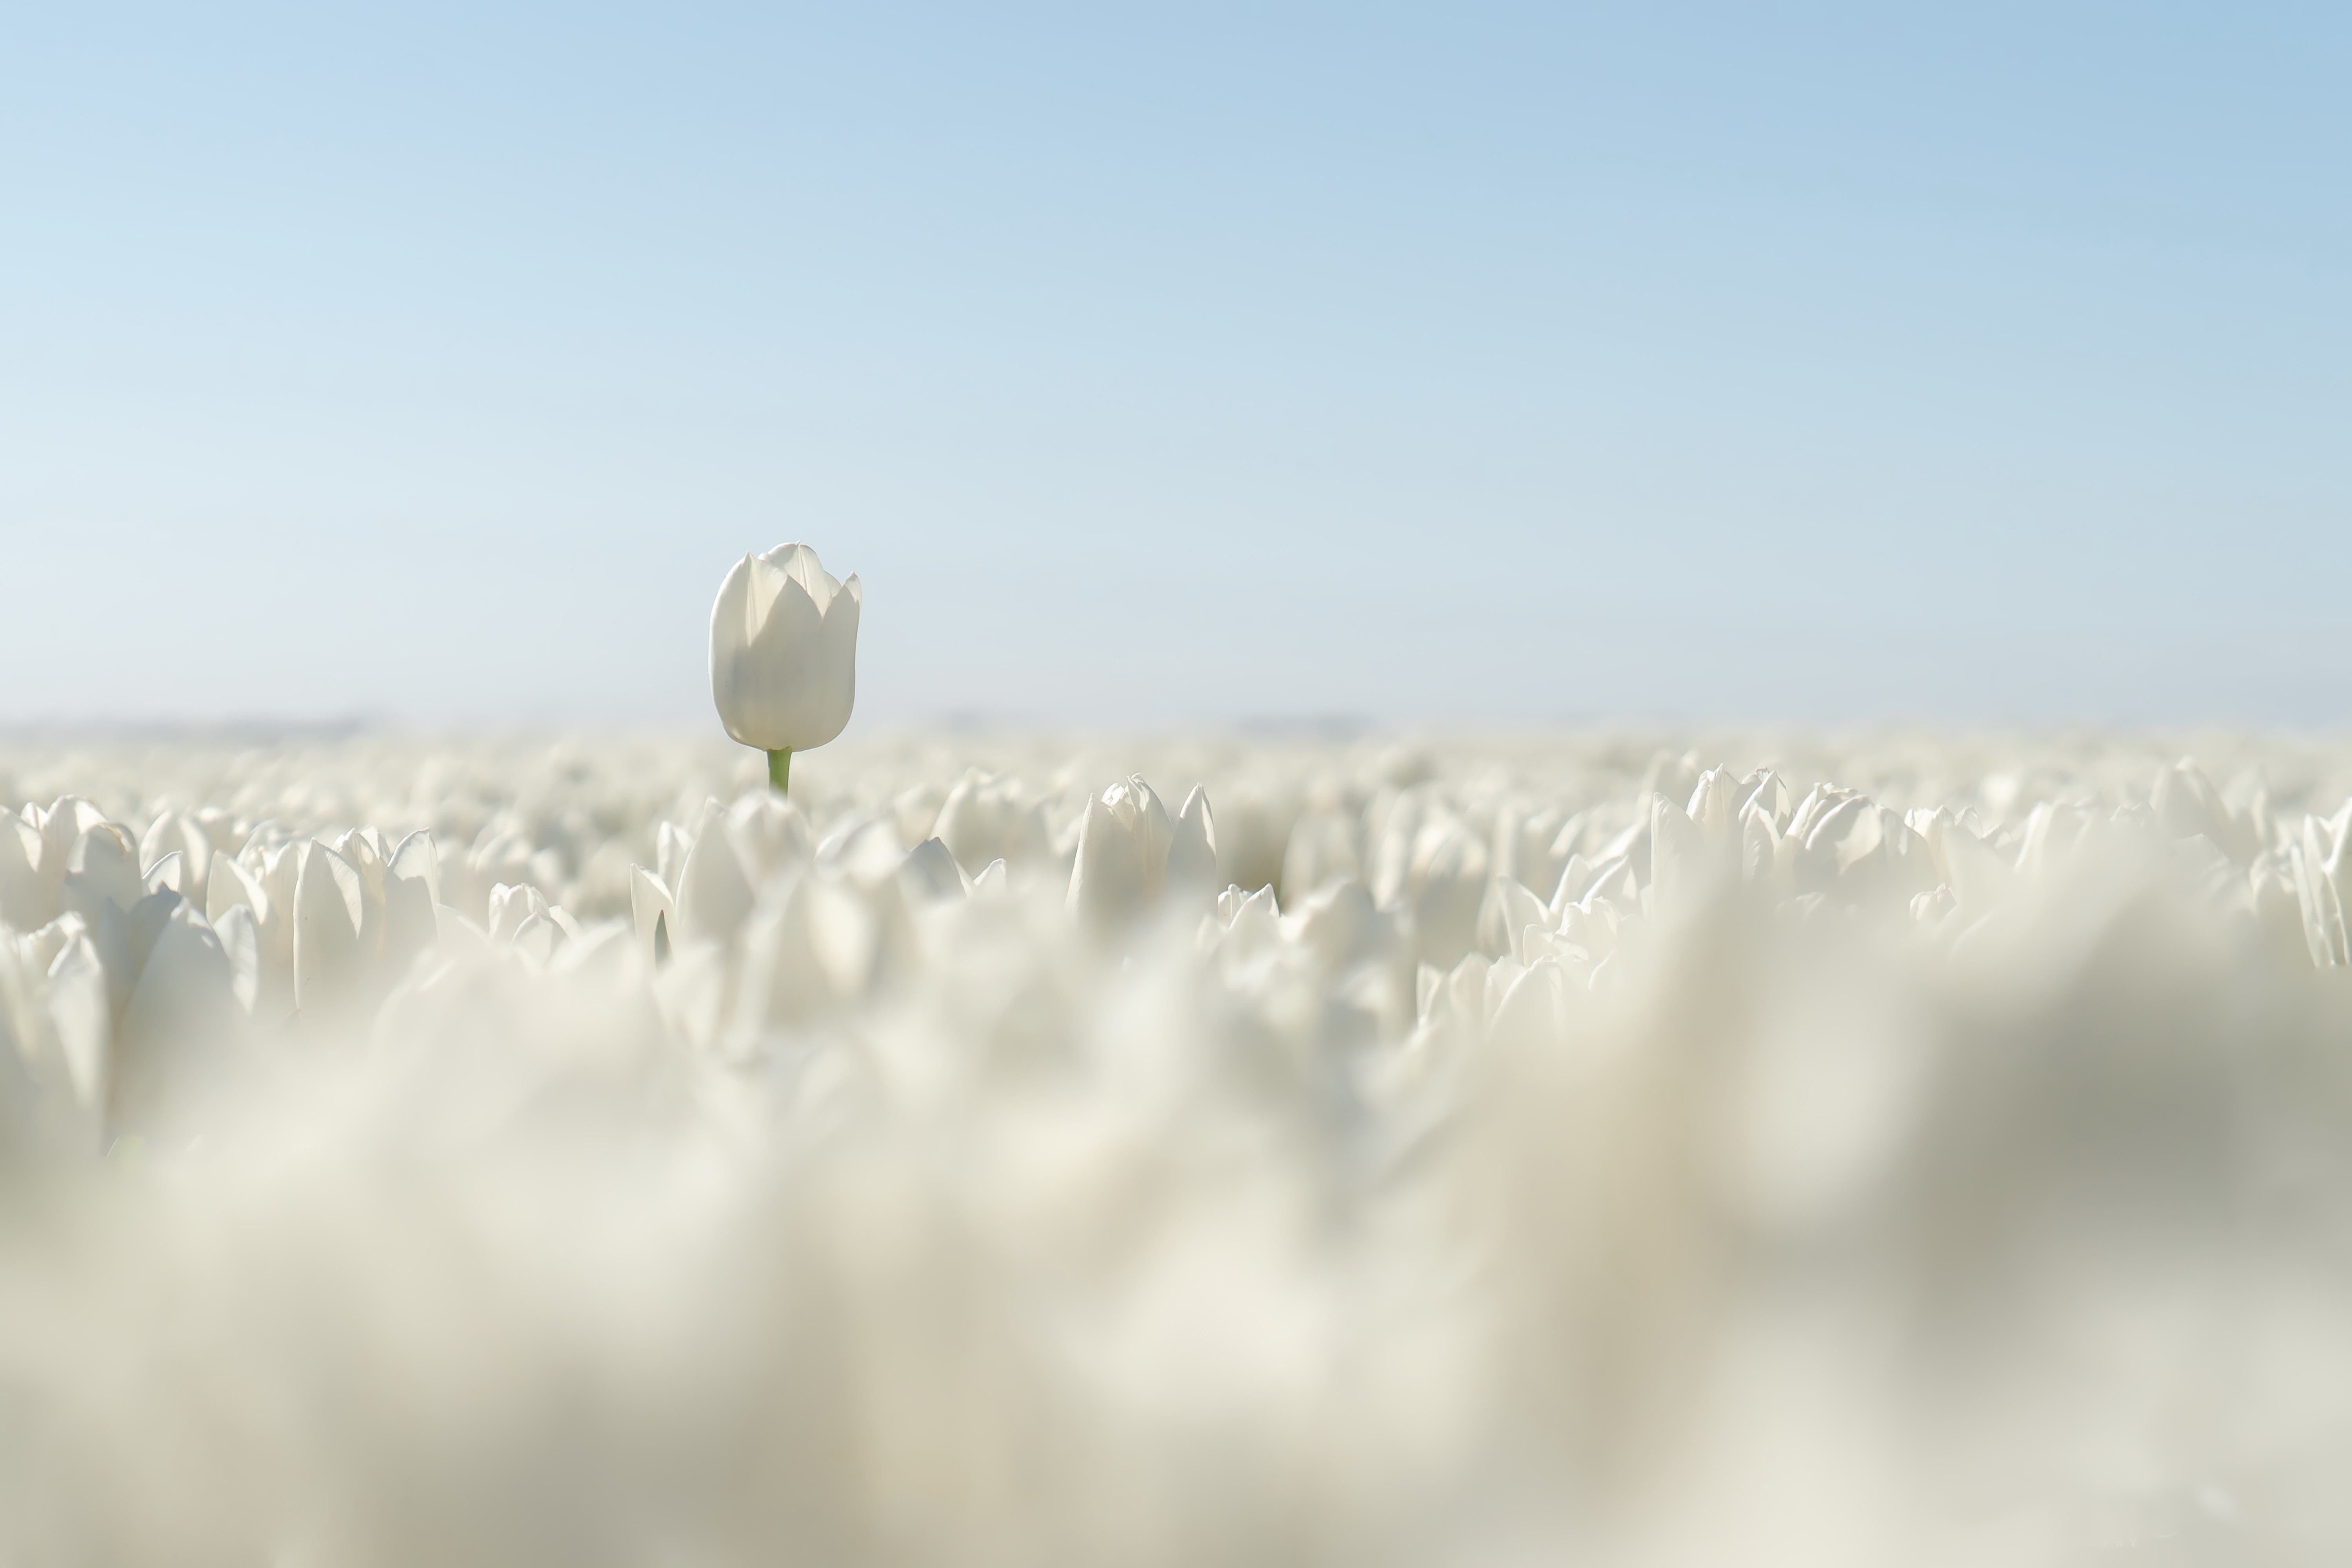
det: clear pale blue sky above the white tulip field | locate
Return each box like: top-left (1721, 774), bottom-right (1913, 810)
top-left (0, 2), bottom-right (2352, 724)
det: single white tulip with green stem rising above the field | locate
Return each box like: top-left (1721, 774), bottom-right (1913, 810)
top-left (710, 543), bottom-right (866, 790)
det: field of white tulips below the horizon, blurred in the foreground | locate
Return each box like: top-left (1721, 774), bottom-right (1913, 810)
top-left (0, 731), bottom-right (2352, 1566)
